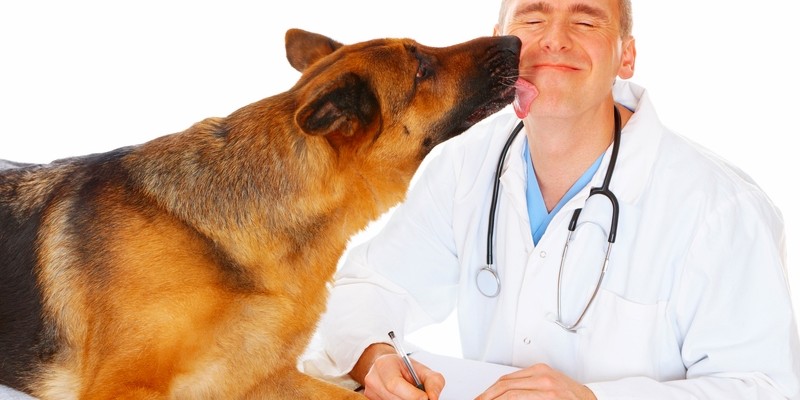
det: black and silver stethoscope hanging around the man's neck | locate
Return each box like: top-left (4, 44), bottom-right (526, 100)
top-left (475, 106), bottom-right (622, 332)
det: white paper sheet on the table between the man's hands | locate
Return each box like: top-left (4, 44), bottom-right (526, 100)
top-left (411, 351), bottom-right (519, 400)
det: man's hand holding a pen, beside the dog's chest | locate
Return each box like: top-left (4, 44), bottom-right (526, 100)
top-left (350, 343), bottom-right (444, 400)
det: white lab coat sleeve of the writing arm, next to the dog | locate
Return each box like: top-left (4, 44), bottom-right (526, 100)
top-left (310, 141), bottom-right (466, 377)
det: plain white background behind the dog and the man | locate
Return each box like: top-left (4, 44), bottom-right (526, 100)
top-left (0, 0), bottom-right (800, 353)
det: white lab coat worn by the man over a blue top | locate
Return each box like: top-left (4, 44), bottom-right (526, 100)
top-left (312, 82), bottom-right (800, 400)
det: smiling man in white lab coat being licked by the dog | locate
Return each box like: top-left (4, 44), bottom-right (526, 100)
top-left (308, 0), bottom-right (800, 399)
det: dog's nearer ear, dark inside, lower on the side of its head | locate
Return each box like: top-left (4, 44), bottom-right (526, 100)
top-left (295, 73), bottom-right (380, 136)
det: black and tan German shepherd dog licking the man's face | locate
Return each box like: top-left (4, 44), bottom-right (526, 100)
top-left (0, 29), bottom-right (520, 399)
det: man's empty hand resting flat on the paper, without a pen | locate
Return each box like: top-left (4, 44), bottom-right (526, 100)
top-left (475, 364), bottom-right (597, 400)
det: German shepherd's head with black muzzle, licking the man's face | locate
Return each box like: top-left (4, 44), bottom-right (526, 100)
top-left (286, 29), bottom-right (520, 169)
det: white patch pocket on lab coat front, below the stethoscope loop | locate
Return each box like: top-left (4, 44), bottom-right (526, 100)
top-left (577, 289), bottom-right (668, 382)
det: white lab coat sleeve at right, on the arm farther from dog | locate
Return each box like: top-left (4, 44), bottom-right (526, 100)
top-left (588, 190), bottom-right (800, 400)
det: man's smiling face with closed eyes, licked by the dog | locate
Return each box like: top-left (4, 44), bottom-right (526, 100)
top-left (495, 0), bottom-right (636, 117)
